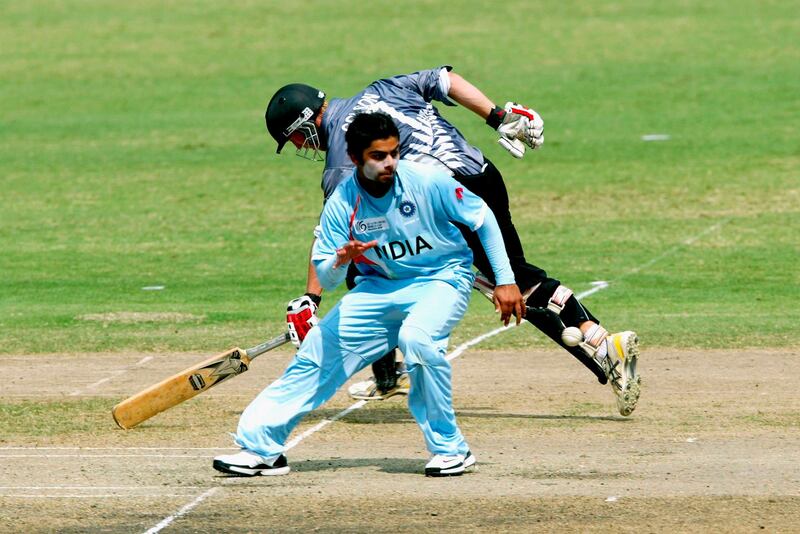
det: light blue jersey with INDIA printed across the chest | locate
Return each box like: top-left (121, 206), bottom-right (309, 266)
top-left (311, 161), bottom-right (494, 289)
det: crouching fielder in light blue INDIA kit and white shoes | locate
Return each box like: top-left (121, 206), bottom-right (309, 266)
top-left (213, 113), bottom-right (525, 476)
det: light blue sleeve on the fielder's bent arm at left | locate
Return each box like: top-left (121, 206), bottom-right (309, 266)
top-left (311, 195), bottom-right (350, 290)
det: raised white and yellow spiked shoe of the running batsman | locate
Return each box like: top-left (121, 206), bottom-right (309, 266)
top-left (601, 330), bottom-right (642, 416)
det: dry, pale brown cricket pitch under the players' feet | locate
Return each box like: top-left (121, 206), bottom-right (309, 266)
top-left (0, 346), bottom-right (800, 532)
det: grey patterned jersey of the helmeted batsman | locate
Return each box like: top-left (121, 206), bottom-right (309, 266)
top-left (321, 66), bottom-right (483, 199)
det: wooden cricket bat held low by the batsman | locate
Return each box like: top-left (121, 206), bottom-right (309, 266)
top-left (111, 332), bottom-right (289, 430)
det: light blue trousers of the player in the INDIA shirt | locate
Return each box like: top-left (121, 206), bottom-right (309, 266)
top-left (236, 278), bottom-right (470, 458)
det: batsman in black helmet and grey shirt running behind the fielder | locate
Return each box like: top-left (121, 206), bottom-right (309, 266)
top-left (266, 66), bottom-right (640, 415)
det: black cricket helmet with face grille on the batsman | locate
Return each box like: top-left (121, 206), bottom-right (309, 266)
top-left (264, 83), bottom-right (325, 154)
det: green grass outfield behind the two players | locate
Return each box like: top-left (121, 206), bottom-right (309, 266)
top-left (0, 0), bottom-right (800, 353)
